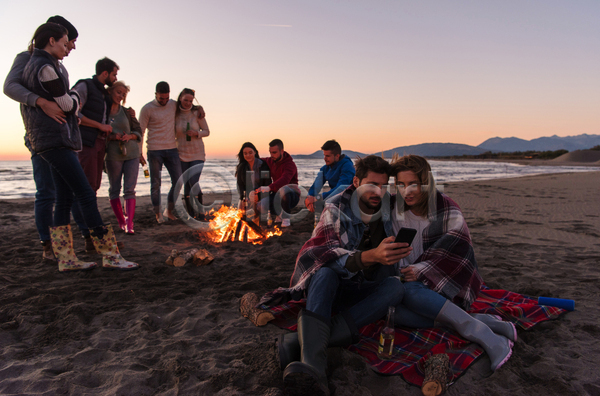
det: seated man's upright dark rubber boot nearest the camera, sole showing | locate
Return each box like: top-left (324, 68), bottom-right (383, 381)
top-left (283, 309), bottom-right (330, 396)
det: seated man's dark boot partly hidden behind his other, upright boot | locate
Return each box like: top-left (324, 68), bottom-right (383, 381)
top-left (275, 312), bottom-right (360, 371)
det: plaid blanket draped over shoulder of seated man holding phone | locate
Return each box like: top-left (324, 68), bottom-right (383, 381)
top-left (259, 185), bottom-right (393, 306)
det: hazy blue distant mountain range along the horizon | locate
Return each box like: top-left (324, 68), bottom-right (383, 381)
top-left (293, 134), bottom-right (600, 159)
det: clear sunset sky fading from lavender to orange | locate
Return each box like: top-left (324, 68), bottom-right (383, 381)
top-left (0, 0), bottom-right (600, 160)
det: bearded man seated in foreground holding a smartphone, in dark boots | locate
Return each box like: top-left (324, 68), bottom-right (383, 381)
top-left (261, 155), bottom-right (412, 396)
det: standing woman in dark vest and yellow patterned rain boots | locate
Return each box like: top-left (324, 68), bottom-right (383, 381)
top-left (21, 22), bottom-right (138, 272)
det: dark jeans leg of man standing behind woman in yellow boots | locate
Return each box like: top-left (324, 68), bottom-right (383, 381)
top-left (31, 154), bottom-right (56, 241)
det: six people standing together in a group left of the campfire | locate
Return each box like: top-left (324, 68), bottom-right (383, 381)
top-left (4, 15), bottom-right (210, 272)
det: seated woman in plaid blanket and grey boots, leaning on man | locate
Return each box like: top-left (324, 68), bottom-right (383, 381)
top-left (392, 155), bottom-right (517, 371)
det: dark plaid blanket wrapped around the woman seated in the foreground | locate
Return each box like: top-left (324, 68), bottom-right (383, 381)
top-left (394, 192), bottom-right (483, 310)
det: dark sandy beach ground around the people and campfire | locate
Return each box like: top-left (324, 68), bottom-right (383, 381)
top-left (0, 172), bottom-right (600, 396)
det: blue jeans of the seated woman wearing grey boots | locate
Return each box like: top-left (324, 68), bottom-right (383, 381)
top-left (394, 282), bottom-right (447, 328)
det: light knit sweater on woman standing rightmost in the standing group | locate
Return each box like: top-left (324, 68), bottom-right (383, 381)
top-left (175, 109), bottom-right (210, 162)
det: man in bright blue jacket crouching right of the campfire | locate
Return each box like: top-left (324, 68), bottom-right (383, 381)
top-left (304, 140), bottom-right (355, 212)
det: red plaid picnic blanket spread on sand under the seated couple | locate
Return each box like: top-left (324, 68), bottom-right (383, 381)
top-left (262, 286), bottom-right (566, 386)
